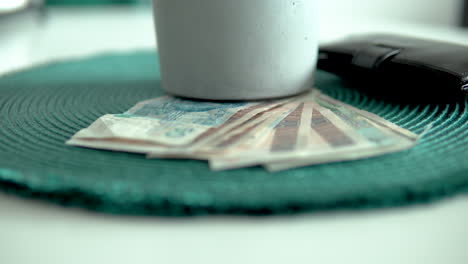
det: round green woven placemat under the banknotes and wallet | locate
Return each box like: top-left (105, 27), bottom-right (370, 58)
top-left (0, 51), bottom-right (468, 216)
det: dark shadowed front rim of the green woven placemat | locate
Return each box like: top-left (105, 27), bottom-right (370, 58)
top-left (0, 168), bottom-right (468, 217)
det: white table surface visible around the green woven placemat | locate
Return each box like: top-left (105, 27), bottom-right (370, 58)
top-left (0, 8), bottom-right (468, 264)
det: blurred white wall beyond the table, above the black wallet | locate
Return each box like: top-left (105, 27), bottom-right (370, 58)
top-left (317, 0), bottom-right (463, 26)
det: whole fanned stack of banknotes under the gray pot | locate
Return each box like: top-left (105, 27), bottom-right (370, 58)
top-left (67, 89), bottom-right (418, 171)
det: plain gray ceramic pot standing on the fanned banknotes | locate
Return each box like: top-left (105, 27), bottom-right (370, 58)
top-left (154, 0), bottom-right (318, 100)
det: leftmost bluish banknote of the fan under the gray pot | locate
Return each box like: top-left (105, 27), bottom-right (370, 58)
top-left (68, 96), bottom-right (292, 146)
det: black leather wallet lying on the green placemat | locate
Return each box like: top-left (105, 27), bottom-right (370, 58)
top-left (317, 34), bottom-right (468, 103)
